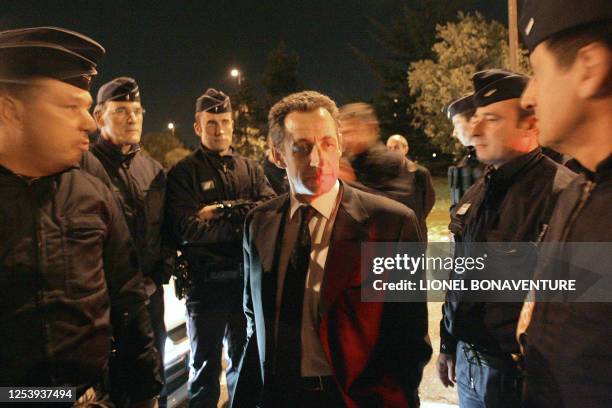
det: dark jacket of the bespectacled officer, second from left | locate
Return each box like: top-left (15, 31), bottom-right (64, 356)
top-left (87, 138), bottom-right (169, 286)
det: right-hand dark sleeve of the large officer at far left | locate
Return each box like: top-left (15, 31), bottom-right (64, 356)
top-left (102, 186), bottom-right (162, 402)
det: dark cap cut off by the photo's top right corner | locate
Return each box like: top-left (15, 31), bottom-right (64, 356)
top-left (518, 0), bottom-right (612, 52)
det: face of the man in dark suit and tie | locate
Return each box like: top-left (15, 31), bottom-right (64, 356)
top-left (273, 108), bottom-right (341, 198)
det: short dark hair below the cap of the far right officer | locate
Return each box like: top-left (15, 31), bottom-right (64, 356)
top-left (545, 20), bottom-right (612, 69)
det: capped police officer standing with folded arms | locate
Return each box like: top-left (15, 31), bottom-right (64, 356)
top-left (166, 89), bottom-right (274, 407)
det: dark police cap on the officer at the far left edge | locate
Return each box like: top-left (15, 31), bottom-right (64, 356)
top-left (0, 27), bottom-right (105, 90)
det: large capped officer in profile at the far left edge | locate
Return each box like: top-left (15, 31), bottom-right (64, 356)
top-left (0, 27), bottom-right (161, 406)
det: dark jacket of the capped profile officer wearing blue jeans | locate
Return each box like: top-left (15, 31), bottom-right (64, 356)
top-left (440, 148), bottom-right (575, 354)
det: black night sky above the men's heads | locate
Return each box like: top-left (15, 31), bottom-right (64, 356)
top-left (0, 0), bottom-right (507, 144)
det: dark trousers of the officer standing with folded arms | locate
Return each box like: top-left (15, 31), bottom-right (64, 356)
top-left (186, 279), bottom-right (246, 408)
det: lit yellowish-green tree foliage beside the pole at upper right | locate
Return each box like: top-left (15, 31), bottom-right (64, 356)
top-left (408, 12), bottom-right (528, 154)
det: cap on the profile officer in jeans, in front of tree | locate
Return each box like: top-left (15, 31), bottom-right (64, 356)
top-left (472, 69), bottom-right (529, 108)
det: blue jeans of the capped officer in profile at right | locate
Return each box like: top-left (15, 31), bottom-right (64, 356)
top-left (456, 342), bottom-right (521, 408)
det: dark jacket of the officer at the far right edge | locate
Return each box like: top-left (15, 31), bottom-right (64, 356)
top-left (525, 156), bottom-right (612, 408)
